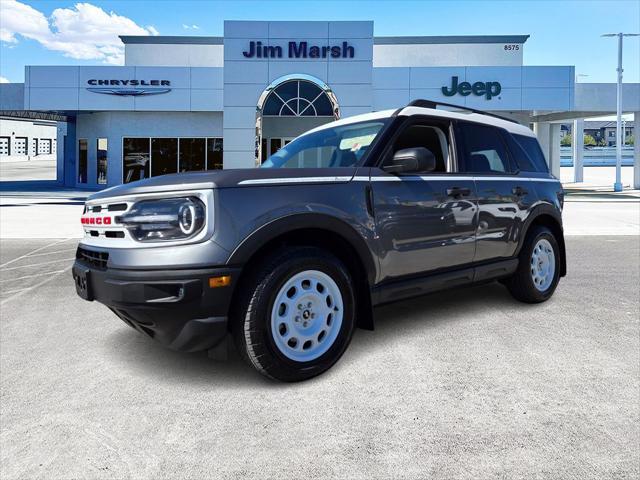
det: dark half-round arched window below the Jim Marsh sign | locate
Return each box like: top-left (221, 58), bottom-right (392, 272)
top-left (262, 80), bottom-right (335, 117)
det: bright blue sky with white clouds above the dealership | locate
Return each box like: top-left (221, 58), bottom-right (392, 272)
top-left (0, 0), bottom-right (640, 82)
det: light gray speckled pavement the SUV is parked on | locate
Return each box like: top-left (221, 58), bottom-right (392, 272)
top-left (0, 236), bottom-right (640, 479)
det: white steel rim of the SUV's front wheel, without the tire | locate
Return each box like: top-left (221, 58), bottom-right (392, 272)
top-left (271, 270), bottom-right (344, 362)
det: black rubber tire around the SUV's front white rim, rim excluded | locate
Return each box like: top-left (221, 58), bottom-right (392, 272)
top-left (232, 247), bottom-right (356, 382)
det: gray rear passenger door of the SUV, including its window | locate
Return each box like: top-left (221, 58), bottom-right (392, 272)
top-left (458, 122), bottom-right (535, 262)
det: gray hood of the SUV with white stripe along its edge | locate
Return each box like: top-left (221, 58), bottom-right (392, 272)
top-left (88, 167), bottom-right (356, 200)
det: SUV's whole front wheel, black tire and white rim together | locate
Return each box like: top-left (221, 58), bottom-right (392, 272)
top-left (232, 247), bottom-right (355, 381)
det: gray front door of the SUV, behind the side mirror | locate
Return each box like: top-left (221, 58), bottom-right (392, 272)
top-left (371, 120), bottom-right (477, 279)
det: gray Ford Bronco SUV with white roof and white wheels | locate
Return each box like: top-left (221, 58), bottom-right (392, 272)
top-left (73, 100), bottom-right (566, 381)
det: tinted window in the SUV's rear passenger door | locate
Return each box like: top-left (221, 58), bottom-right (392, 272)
top-left (460, 123), bottom-right (511, 173)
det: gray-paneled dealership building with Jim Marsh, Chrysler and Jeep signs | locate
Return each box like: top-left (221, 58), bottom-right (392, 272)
top-left (0, 21), bottom-right (640, 188)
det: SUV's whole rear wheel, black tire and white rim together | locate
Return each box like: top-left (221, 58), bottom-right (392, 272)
top-left (504, 226), bottom-right (560, 303)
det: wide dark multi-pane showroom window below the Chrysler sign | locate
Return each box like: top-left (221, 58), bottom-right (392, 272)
top-left (122, 137), bottom-right (223, 183)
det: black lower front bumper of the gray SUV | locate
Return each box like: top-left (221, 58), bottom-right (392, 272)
top-left (72, 255), bottom-right (240, 352)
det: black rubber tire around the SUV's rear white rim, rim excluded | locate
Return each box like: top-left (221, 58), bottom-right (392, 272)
top-left (503, 225), bottom-right (560, 303)
